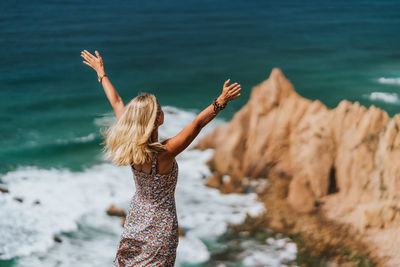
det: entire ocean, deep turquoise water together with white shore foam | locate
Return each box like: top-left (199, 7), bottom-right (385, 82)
top-left (0, 0), bottom-right (400, 266)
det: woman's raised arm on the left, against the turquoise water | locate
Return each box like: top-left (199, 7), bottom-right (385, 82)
top-left (81, 50), bottom-right (125, 120)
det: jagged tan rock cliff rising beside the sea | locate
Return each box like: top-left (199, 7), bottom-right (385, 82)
top-left (197, 69), bottom-right (400, 266)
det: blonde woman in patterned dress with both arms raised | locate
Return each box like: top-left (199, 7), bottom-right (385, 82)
top-left (81, 50), bottom-right (241, 266)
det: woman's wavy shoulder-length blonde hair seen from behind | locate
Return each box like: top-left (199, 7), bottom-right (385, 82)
top-left (101, 93), bottom-right (166, 166)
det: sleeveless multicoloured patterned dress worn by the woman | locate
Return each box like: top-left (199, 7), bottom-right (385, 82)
top-left (113, 153), bottom-right (179, 267)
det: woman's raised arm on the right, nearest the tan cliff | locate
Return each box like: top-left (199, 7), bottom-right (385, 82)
top-left (164, 79), bottom-right (242, 158)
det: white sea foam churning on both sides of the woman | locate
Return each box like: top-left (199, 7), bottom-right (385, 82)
top-left (0, 107), bottom-right (294, 266)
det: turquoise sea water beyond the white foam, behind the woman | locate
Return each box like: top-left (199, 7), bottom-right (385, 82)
top-left (0, 0), bottom-right (400, 266)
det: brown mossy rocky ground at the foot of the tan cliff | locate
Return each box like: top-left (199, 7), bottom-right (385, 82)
top-left (232, 174), bottom-right (376, 267)
